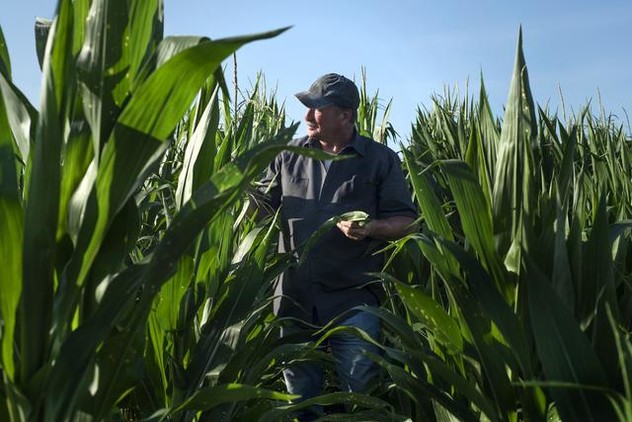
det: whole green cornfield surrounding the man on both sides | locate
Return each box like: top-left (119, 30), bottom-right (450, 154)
top-left (0, 0), bottom-right (632, 422)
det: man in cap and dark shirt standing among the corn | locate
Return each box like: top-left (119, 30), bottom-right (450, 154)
top-left (254, 73), bottom-right (417, 418)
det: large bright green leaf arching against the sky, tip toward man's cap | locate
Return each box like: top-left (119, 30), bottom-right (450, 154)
top-left (63, 26), bottom-right (292, 322)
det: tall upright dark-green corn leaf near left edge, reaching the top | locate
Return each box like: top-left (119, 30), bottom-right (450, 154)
top-left (19, 0), bottom-right (73, 382)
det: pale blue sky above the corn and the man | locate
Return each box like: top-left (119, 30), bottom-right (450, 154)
top-left (0, 0), bottom-right (632, 139)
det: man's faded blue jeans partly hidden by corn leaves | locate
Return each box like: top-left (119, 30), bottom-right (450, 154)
top-left (282, 312), bottom-right (380, 420)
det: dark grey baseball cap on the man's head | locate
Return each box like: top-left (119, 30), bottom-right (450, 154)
top-left (296, 73), bottom-right (360, 110)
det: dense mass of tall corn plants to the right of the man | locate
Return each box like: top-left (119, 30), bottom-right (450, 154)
top-left (380, 28), bottom-right (632, 421)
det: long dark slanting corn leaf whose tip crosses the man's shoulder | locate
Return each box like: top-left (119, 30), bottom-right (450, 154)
top-left (46, 128), bottom-right (295, 420)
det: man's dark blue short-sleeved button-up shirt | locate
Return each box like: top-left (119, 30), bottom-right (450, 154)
top-left (261, 135), bottom-right (417, 323)
